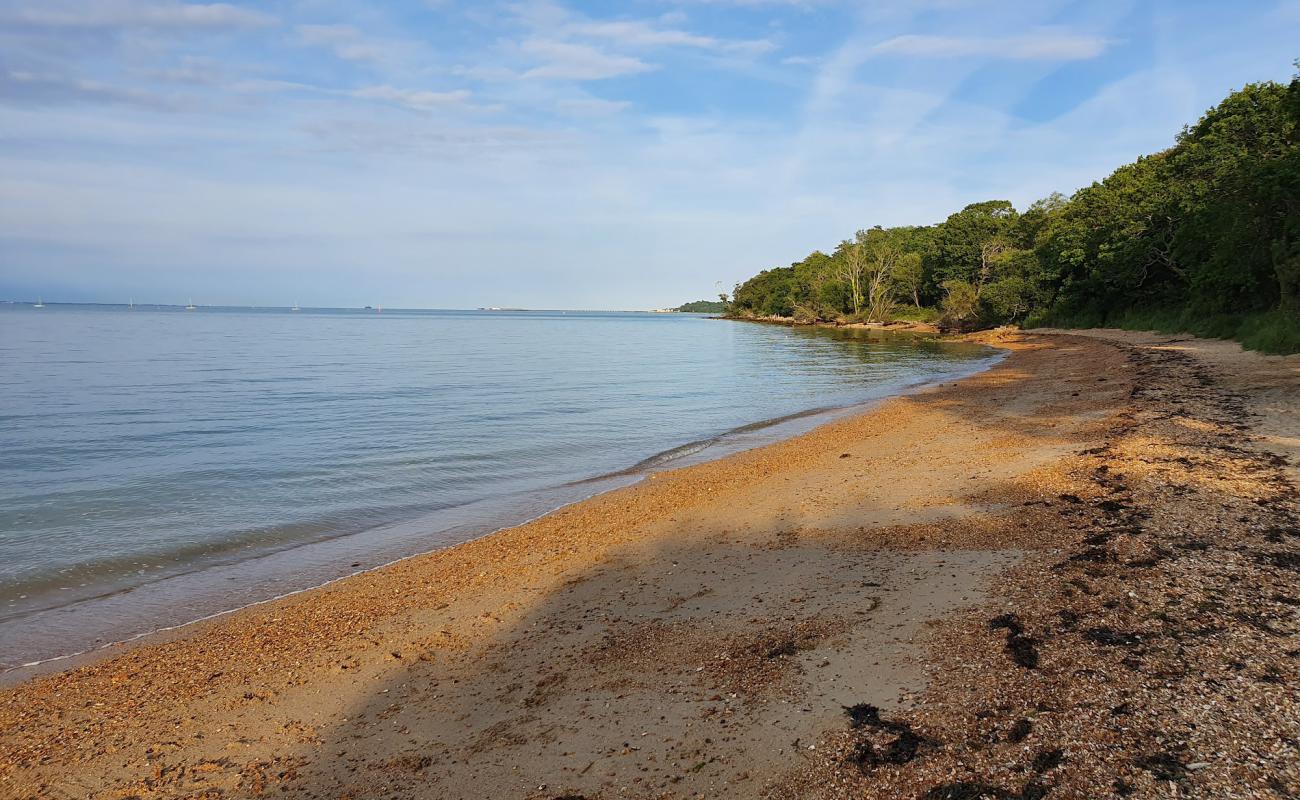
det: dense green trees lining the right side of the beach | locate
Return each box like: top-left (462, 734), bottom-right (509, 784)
top-left (728, 71), bottom-right (1300, 353)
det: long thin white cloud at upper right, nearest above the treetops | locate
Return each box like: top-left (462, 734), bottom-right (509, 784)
top-left (871, 30), bottom-right (1110, 61)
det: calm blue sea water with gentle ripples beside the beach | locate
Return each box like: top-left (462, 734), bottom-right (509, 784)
top-left (0, 304), bottom-right (996, 669)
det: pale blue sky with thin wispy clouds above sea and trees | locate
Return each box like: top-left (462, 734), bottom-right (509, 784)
top-left (0, 0), bottom-right (1300, 308)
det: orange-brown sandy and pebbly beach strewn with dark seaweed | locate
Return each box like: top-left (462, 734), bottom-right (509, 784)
top-left (0, 332), bottom-right (1300, 800)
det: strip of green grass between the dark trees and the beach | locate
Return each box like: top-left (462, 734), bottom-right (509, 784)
top-left (1026, 308), bottom-right (1300, 355)
